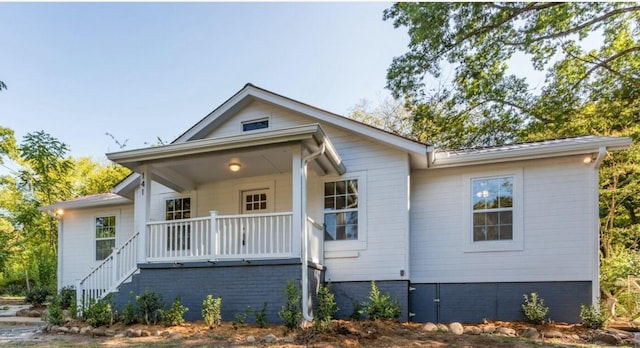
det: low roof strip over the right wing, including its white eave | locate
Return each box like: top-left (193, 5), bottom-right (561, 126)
top-left (430, 135), bottom-right (632, 168)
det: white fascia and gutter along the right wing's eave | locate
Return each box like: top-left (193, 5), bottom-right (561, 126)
top-left (430, 137), bottom-right (632, 168)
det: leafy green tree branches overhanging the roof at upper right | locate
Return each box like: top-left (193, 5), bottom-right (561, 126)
top-left (383, 2), bottom-right (640, 146)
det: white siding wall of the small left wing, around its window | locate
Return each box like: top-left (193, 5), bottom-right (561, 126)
top-left (60, 204), bottom-right (134, 286)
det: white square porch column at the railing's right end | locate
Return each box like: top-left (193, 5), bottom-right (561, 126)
top-left (291, 144), bottom-right (303, 256)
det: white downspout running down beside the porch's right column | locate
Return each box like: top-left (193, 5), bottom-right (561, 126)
top-left (300, 142), bottom-right (325, 322)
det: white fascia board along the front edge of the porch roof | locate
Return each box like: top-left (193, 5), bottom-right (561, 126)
top-left (107, 123), bottom-right (320, 166)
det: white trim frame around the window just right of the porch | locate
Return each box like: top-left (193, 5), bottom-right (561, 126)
top-left (320, 171), bottom-right (368, 252)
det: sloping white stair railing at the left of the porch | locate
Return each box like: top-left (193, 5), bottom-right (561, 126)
top-left (76, 233), bottom-right (139, 310)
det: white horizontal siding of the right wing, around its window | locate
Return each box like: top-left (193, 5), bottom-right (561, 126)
top-left (410, 156), bottom-right (598, 283)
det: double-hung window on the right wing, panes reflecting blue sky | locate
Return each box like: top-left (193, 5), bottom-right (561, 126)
top-left (472, 176), bottom-right (513, 242)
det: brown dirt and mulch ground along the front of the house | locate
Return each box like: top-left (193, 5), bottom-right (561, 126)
top-left (0, 320), bottom-right (604, 348)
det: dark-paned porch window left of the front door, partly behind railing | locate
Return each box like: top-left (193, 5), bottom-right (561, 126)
top-left (165, 197), bottom-right (191, 250)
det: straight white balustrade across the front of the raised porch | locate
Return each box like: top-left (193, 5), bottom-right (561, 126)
top-left (147, 212), bottom-right (294, 262)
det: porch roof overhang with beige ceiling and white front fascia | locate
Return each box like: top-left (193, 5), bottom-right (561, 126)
top-left (107, 124), bottom-right (346, 191)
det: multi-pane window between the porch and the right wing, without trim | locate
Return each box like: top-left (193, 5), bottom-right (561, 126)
top-left (324, 179), bottom-right (358, 241)
